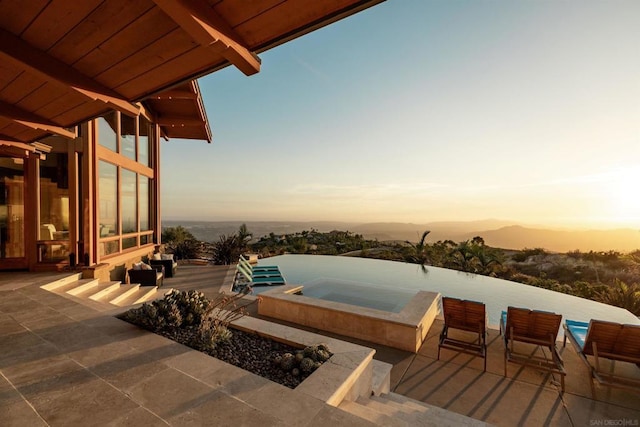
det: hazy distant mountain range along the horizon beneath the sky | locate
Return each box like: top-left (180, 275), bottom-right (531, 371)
top-left (163, 219), bottom-right (640, 252)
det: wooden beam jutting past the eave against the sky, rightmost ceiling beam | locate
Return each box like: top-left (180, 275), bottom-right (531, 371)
top-left (153, 0), bottom-right (260, 76)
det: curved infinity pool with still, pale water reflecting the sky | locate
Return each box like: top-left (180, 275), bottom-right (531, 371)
top-left (254, 255), bottom-right (640, 325)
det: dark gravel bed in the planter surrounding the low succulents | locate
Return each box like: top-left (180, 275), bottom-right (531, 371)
top-left (144, 328), bottom-right (306, 388)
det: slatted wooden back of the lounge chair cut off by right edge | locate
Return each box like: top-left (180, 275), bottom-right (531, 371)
top-left (582, 320), bottom-right (640, 363)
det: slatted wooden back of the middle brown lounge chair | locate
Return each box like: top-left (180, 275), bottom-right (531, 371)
top-left (504, 307), bottom-right (562, 345)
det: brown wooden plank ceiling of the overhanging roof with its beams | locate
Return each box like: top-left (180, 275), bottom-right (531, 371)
top-left (0, 0), bottom-right (383, 150)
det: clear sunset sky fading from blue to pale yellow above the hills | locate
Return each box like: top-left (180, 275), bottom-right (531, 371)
top-left (162, 0), bottom-right (640, 228)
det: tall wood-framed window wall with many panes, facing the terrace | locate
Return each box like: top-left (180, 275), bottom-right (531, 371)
top-left (97, 113), bottom-right (155, 256)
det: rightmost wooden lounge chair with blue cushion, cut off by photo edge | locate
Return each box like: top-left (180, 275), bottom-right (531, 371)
top-left (563, 320), bottom-right (640, 398)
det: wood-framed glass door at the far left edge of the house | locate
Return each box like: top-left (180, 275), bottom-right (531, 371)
top-left (0, 156), bottom-right (26, 269)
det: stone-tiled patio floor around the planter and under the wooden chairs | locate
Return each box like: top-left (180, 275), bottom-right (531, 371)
top-left (0, 266), bottom-right (640, 426)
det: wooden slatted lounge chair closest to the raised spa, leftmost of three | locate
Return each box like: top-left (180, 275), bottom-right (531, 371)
top-left (438, 297), bottom-right (487, 371)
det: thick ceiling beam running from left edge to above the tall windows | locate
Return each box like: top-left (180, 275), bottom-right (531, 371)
top-left (0, 29), bottom-right (140, 116)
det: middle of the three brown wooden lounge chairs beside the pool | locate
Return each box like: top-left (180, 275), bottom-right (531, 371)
top-left (500, 307), bottom-right (566, 392)
